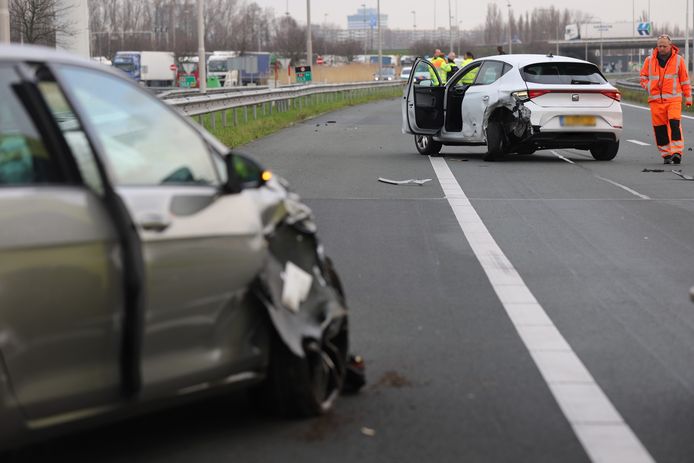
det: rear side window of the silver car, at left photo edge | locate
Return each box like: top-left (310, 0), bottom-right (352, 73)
top-left (0, 65), bottom-right (61, 186)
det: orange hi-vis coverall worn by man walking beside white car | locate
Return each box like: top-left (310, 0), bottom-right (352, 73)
top-left (641, 45), bottom-right (692, 158)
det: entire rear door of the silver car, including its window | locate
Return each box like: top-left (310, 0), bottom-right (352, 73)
top-left (0, 62), bottom-right (125, 420)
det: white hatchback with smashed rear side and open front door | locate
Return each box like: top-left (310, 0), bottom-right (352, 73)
top-left (402, 54), bottom-right (622, 161)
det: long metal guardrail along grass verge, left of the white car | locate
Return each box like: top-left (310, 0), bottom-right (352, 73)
top-left (164, 81), bottom-right (404, 121)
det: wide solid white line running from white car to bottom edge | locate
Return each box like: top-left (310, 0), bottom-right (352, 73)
top-left (429, 157), bottom-right (654, 463)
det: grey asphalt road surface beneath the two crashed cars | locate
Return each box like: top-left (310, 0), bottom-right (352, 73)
top-left (16, 101), bottom-right (694, 463)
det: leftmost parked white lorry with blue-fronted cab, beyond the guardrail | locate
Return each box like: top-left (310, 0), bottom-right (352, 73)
top-left (113, 51), bottom-right (176, 87)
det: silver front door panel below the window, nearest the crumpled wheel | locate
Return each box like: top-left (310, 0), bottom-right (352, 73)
top-left (117, 186), bottom-right (267, 397)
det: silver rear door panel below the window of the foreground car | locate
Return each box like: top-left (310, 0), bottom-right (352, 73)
top-left (0, 187), bottom-right (123, 420)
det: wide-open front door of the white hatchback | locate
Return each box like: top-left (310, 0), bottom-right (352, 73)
top-left (402, 58), bottom-right (446, 135)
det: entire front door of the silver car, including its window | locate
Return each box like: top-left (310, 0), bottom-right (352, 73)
top-left (47, 65), bottom-right (267, 395)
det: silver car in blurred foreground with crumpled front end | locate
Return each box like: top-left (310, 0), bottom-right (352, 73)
top-left (0, 46), bottom-right (362, 447)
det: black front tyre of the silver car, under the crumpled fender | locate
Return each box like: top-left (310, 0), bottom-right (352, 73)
top-left (265, 317), bottom-right (348, 418)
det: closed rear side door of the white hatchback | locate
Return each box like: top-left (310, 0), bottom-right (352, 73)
top-left (462, 60), bottom-right (510, 142)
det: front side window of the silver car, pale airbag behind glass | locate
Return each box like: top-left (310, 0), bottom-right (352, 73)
top-left (59, 66), bottom-right (220, 186)
